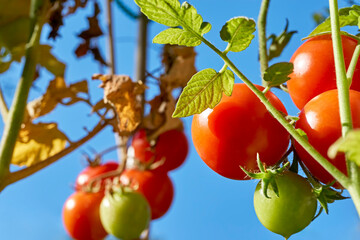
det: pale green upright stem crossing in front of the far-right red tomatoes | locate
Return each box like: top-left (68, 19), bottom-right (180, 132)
top-left (329, 0), bottom-right (360, 216)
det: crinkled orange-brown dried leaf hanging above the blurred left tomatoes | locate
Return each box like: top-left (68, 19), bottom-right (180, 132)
top-left (93, 74), bottom-right (146, 136)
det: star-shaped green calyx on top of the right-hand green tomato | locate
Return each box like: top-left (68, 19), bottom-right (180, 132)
top-left (240, 154), bottom-right (290, 198)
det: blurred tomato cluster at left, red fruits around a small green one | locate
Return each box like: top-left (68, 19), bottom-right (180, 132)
top-left (63, 129), bottom-right (188, 240)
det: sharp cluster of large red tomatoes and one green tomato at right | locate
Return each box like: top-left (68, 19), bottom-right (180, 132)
top-left (192, 34), bottom-right (360, 239)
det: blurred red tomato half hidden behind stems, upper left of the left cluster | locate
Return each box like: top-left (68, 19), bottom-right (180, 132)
top-left (75, 162), bottom-right (119, 190)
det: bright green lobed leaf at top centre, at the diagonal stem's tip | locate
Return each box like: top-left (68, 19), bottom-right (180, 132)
top-left (135, 0), bottom-right (211, 46)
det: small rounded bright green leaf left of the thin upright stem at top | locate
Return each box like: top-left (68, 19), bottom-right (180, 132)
top-left (220, 17), bottom-right (256, 52)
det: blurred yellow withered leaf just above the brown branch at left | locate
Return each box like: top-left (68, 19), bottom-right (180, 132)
top-left (11, 123), bottom-right (67, 167)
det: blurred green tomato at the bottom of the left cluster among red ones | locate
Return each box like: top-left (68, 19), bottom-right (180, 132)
top-left (100, 189), bottom-right (151, 240)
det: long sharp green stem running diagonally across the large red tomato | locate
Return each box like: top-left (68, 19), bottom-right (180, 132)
top-left (198, 35), bottom-right (349, 188)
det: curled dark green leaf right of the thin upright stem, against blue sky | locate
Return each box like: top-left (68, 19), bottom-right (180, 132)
top-left (268, 20), bottom-right (297, 61)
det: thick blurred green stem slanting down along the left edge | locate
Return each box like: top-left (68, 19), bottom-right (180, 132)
top-left (0, 0), bottom-right (42, 181)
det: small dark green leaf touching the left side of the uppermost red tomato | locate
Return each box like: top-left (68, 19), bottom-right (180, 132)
top-left (264, 62), bottom-right (294, 87)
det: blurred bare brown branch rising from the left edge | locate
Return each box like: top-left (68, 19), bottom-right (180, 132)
top-left (0, 120), bottom-right (109, 189)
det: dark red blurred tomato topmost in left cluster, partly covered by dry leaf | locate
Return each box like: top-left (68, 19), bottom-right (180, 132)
top-left (131, 129), bottom-right (188, 173)
